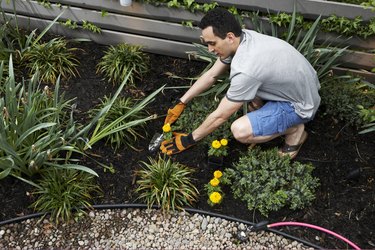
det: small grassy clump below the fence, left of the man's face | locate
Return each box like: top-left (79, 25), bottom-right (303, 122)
top-left (96, 43), bottom-right (150, 85)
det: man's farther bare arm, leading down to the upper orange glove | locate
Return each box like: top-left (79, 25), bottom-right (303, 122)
top-left (180, 58), bottom-right (229, 104)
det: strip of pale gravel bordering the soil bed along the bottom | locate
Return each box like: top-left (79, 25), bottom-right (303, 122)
top-left (0, 209), bottom-right (313, 250)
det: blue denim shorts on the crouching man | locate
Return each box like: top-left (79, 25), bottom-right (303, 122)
top-left (247, 101), bottom-right (310, 136)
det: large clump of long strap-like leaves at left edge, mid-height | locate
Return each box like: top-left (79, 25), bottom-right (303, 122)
top-left (0, 58), bottom-right (96, 184)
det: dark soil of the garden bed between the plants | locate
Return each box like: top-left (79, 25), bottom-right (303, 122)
top-left (0, 40), bottom-right (375, 249)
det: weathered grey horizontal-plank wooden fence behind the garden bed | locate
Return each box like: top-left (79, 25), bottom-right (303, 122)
top-left (1, 0), bottom-right (375, 82)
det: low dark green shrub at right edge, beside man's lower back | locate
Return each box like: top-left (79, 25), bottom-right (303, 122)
top-left (320, 81), bottom-right (375, 127)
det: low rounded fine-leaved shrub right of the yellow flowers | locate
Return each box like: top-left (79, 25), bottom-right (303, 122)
top-left (222, 147), bottom-right (319, 216)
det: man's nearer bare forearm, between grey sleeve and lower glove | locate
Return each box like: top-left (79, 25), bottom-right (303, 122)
top-left (192, 96), bottom-right (243, 141)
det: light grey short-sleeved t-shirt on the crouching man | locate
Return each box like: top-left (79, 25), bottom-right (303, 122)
top-left (223, 30), bottom-right (320, 118)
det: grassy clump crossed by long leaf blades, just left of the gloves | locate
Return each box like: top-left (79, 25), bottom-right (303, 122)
top-left (89, 96), bottom-right (148, 149)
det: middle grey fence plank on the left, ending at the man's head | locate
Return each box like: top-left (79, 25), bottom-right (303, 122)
top-left (3, 1), bottom-right (200, 43)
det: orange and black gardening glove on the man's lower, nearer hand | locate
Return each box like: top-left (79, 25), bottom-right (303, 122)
top-left (160, 133), bottom-right (196, 155)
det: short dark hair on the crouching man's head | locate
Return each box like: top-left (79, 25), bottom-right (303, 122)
top-left (198, 8), bottom-right (242, 39)
